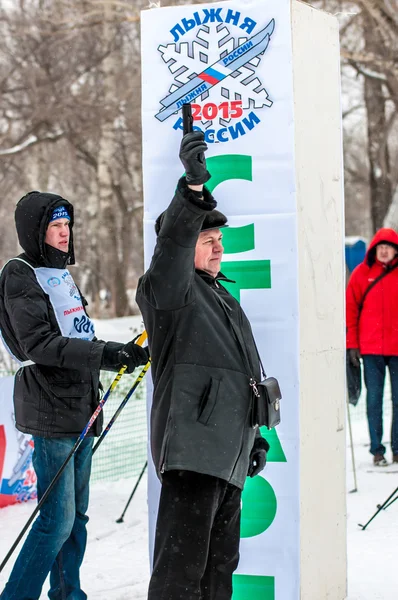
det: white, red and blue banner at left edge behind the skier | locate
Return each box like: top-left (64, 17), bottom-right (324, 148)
top-left (0, 377), bottom-right (37, 508)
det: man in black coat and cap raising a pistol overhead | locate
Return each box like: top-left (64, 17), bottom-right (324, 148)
top-left (137, 132), bottom-right (269, 600)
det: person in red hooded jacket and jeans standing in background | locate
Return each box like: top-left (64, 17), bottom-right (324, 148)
top-left (346, 228), bottom-right (398, 466)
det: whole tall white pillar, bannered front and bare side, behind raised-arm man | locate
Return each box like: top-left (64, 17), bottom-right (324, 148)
top-left (141, 0), bottom-right (346, 600)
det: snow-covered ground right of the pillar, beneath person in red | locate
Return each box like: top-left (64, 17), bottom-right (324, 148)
top-left (347, 398), bottom-right (398, 600)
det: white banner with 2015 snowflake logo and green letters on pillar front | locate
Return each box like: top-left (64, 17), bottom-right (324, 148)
top-left (142, 0), bottom-right (300, 600)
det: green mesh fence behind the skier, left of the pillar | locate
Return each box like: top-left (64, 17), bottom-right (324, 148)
top-left (0, 367), bottom-right (150, 481)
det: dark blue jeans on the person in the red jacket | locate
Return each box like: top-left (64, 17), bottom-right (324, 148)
top-left (362, 354), bottom-right (398, 455)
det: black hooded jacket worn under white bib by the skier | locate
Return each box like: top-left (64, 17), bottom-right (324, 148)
top-left (0, 192), bottom-right (105, 437)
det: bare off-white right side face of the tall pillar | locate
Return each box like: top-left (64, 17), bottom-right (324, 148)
top-left (292, 1), bottom-right (347, 600)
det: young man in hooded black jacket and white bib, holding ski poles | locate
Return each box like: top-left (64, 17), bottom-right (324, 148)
top-left (0, 192), bottom-right (148, 600)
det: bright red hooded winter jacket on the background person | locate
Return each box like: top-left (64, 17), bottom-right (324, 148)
top-left (346, 229), bottom-right (398, 356)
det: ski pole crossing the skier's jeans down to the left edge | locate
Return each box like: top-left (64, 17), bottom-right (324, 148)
top-left (0, 331), bottom-right (147, 573)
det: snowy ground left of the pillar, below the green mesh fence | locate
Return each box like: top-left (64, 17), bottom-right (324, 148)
top-left (0, 478), bottom-right (149, 600)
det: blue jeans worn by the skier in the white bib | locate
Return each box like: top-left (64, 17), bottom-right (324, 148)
top-left (0, 436), bottom-right (93, 600)
